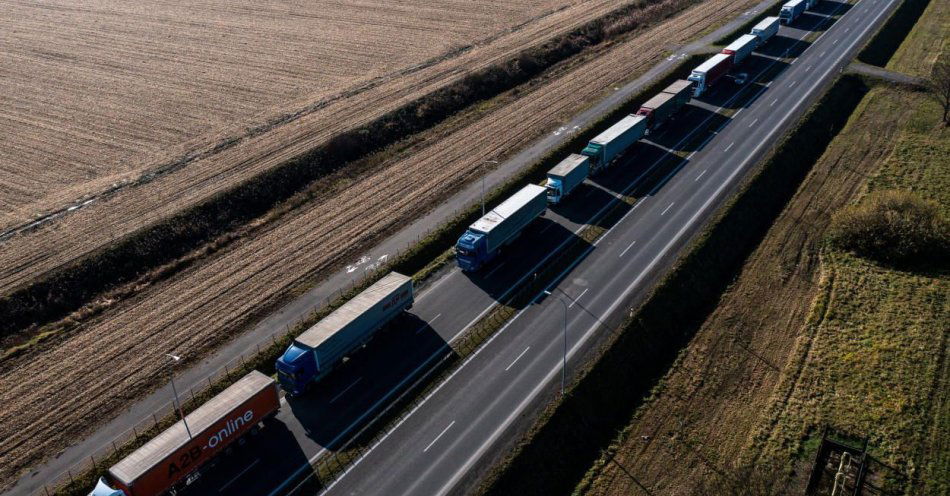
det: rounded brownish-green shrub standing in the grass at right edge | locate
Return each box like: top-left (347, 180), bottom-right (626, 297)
top-left (829, 190), bottom-right (950, 265)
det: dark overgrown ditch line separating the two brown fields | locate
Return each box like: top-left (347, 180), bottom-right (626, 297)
top-left (0, 0), bottom-right (708, 344)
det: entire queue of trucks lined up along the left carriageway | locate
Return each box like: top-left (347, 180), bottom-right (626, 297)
top-left (90, 5), bottom-right (817, 496)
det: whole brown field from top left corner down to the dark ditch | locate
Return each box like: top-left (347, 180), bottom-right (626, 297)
top-left (0, 0), bottom-right (623, 294)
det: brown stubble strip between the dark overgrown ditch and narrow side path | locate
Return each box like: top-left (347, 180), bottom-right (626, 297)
top-left (0, 0), bottom-right (755, 488)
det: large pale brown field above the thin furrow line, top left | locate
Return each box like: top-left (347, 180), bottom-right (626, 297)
top-left (0, 0), bottom-right (584, 230)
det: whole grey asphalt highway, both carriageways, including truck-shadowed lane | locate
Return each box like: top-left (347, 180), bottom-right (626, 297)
top-left (44, 0), bottom-right (896, 495)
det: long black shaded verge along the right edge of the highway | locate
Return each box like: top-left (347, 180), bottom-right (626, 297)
top-left (479, 76), bottom-right (867, 495)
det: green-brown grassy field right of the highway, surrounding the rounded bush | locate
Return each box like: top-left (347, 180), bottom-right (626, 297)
top-left (582, 7), bottom-right (950, 495)
